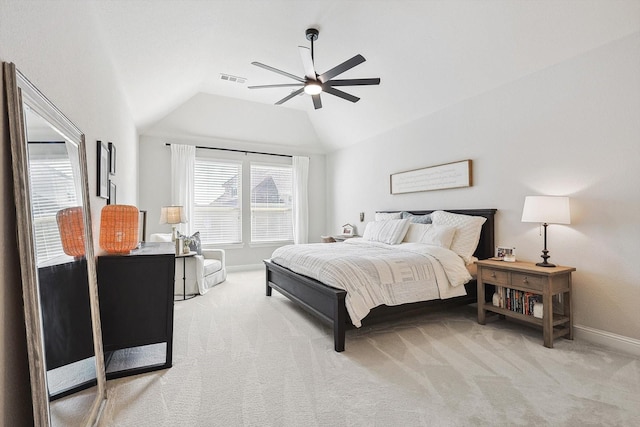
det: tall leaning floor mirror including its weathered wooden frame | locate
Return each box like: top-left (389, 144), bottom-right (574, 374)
top-left (3, 63), bottom-right (106, 426)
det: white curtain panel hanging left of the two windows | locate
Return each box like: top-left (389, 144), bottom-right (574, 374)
top-left (171, 144), bottom-right (196, 236)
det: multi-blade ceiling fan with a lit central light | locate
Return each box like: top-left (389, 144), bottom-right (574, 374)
top-left (249, 28), bottom-right (380, 110)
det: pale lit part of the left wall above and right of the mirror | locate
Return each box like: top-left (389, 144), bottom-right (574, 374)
top-left (0, 2), bottom-right (138, 250)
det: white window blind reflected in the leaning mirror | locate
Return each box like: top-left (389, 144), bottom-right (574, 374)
top-left (29, 143), bottom-right (80, 265)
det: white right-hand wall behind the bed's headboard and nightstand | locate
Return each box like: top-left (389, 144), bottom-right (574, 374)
top-left (327, 33), bottom-right (640, 343)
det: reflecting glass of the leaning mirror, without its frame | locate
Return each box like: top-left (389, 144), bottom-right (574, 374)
top-left (24, 114), bottom-right (96, 400)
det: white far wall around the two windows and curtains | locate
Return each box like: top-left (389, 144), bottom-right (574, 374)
top-left (139, 135), bottom-right (326, 266)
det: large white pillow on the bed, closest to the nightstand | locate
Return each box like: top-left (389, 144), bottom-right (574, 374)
top-left (431, 211), bottom-right (487, 264)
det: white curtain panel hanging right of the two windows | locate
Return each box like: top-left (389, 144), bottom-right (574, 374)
top-left (292, 156), bottom-right (309, 244)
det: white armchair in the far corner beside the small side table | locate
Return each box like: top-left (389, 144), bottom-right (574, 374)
top-left (149, 233), bottom-right (227, 295)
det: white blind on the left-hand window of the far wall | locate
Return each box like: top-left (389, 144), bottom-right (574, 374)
top-left (191, 156), bottom-right (242, 244)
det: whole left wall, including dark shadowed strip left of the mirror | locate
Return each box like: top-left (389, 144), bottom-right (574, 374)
top-left (0, 1), bottom-right (138, 426)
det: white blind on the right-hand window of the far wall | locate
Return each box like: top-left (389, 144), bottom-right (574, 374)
top-left (251, 163), bottom-right (293, 243)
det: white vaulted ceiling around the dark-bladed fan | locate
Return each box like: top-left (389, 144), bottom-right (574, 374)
top-left (94, 0), bottom-right (640, 154)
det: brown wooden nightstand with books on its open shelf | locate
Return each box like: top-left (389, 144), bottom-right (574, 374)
top-left (476, 260), bottom-right (576, 348)
